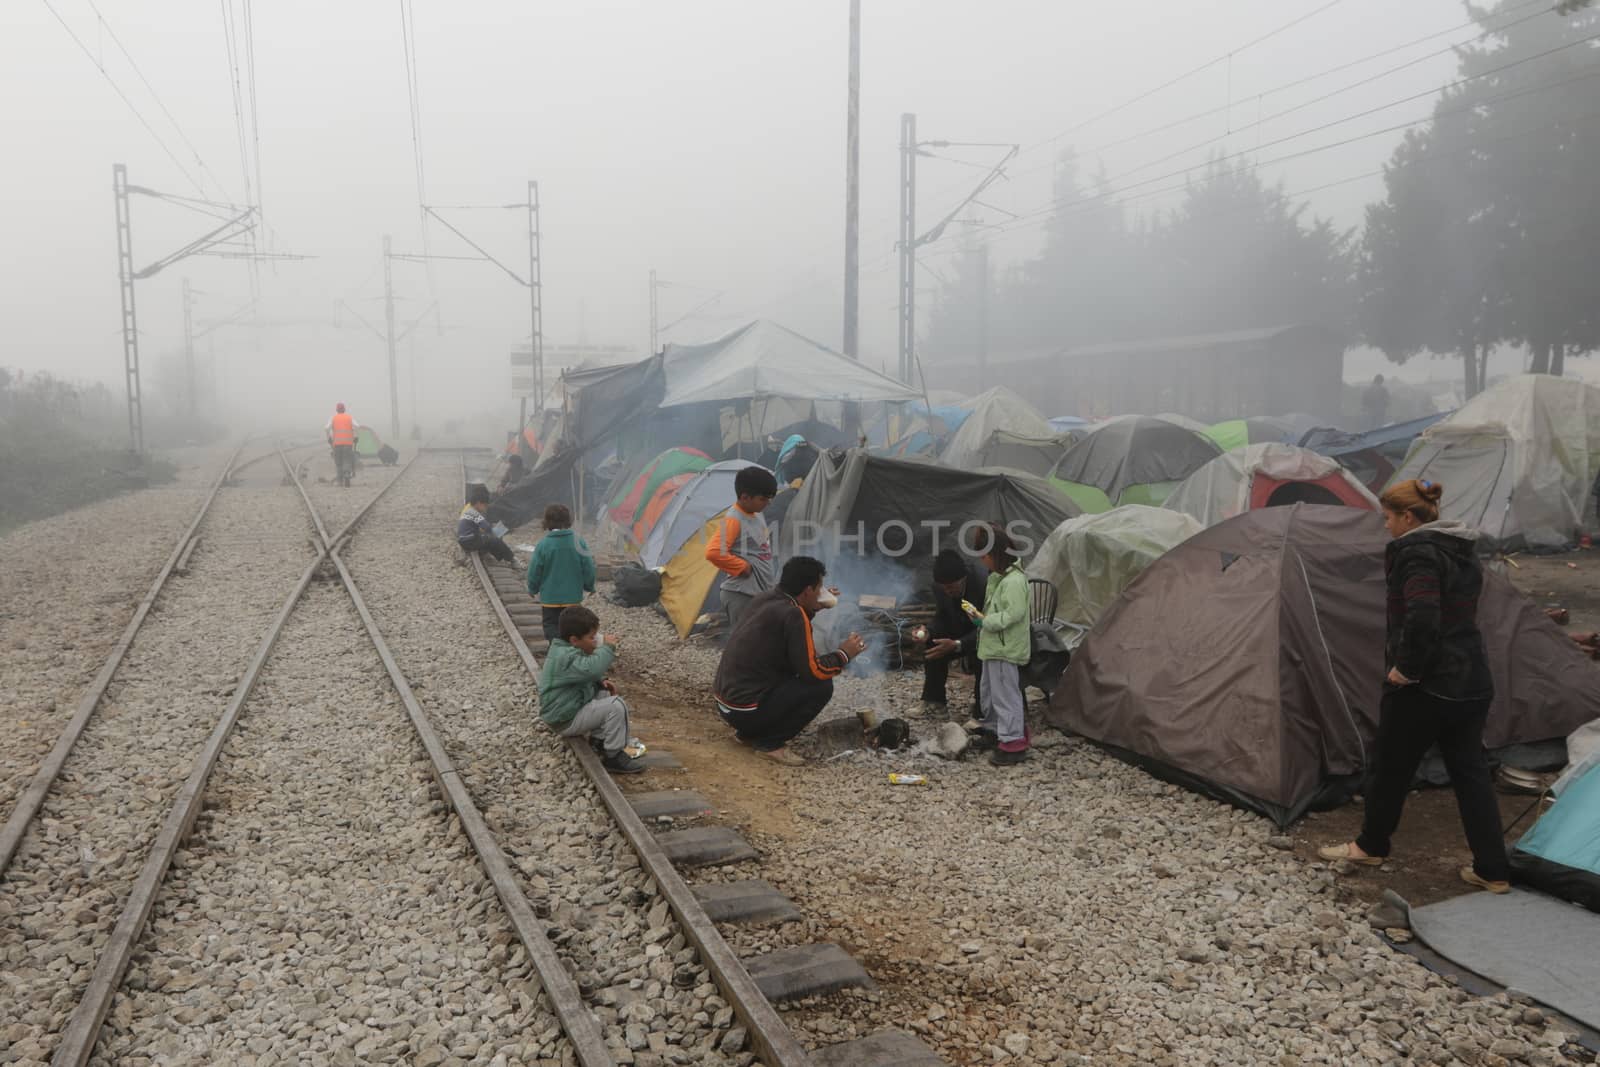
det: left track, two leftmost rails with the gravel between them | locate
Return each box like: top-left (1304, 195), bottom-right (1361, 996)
top-left (0, 450), bottom-right (432, 1062)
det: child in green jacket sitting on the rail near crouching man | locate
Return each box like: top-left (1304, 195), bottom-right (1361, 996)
top-left (539, 606), bottom-right (645, 774)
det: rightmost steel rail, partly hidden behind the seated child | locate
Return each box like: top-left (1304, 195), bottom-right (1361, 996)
top-left (470, 552), bottom-right (808, 1067)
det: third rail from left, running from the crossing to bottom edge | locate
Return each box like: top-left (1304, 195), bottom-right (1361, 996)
top-left (285, 450), bottom-right (616, 1067)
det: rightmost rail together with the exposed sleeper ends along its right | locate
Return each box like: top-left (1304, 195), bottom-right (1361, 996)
top-left (462, 464), bottom-right (944, 1067)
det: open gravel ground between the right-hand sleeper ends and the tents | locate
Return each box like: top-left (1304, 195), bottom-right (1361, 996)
top-left (597, 601), bottom-right (1579, 1065)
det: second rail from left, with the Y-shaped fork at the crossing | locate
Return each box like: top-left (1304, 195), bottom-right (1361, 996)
top-left (50, 450), bottom-right (416, 1067)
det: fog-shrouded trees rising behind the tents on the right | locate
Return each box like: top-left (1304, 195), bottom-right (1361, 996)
top-left (923, 0), bottom-right (1600, 395)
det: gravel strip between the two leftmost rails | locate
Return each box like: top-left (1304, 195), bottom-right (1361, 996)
top-left (0, 457), bottom-right (312, 1062)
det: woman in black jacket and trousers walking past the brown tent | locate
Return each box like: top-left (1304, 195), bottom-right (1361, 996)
top-left (1318, 480), bottom-right (1510, 893)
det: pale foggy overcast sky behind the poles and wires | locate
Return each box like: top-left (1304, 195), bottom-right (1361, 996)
top-left (0, 0), bottom-right (1470, 426)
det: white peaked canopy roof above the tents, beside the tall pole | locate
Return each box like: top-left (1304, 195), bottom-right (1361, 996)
top-left (661, 318), bottom-right (922, 408)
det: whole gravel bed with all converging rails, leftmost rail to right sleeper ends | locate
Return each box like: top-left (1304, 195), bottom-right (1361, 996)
top-left (0, 444), bottom-right (939, 1067)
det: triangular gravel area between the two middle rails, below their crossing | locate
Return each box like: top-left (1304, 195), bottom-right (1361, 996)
top-left (99, 579), bottom-right (570, 1067)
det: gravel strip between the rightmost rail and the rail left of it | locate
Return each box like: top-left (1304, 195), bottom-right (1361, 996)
top-left (346, 456), bottom-right (750, 1067)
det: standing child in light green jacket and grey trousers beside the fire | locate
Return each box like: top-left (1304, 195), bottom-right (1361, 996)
top-left (968, 523), bottom-right (1032, 766)
